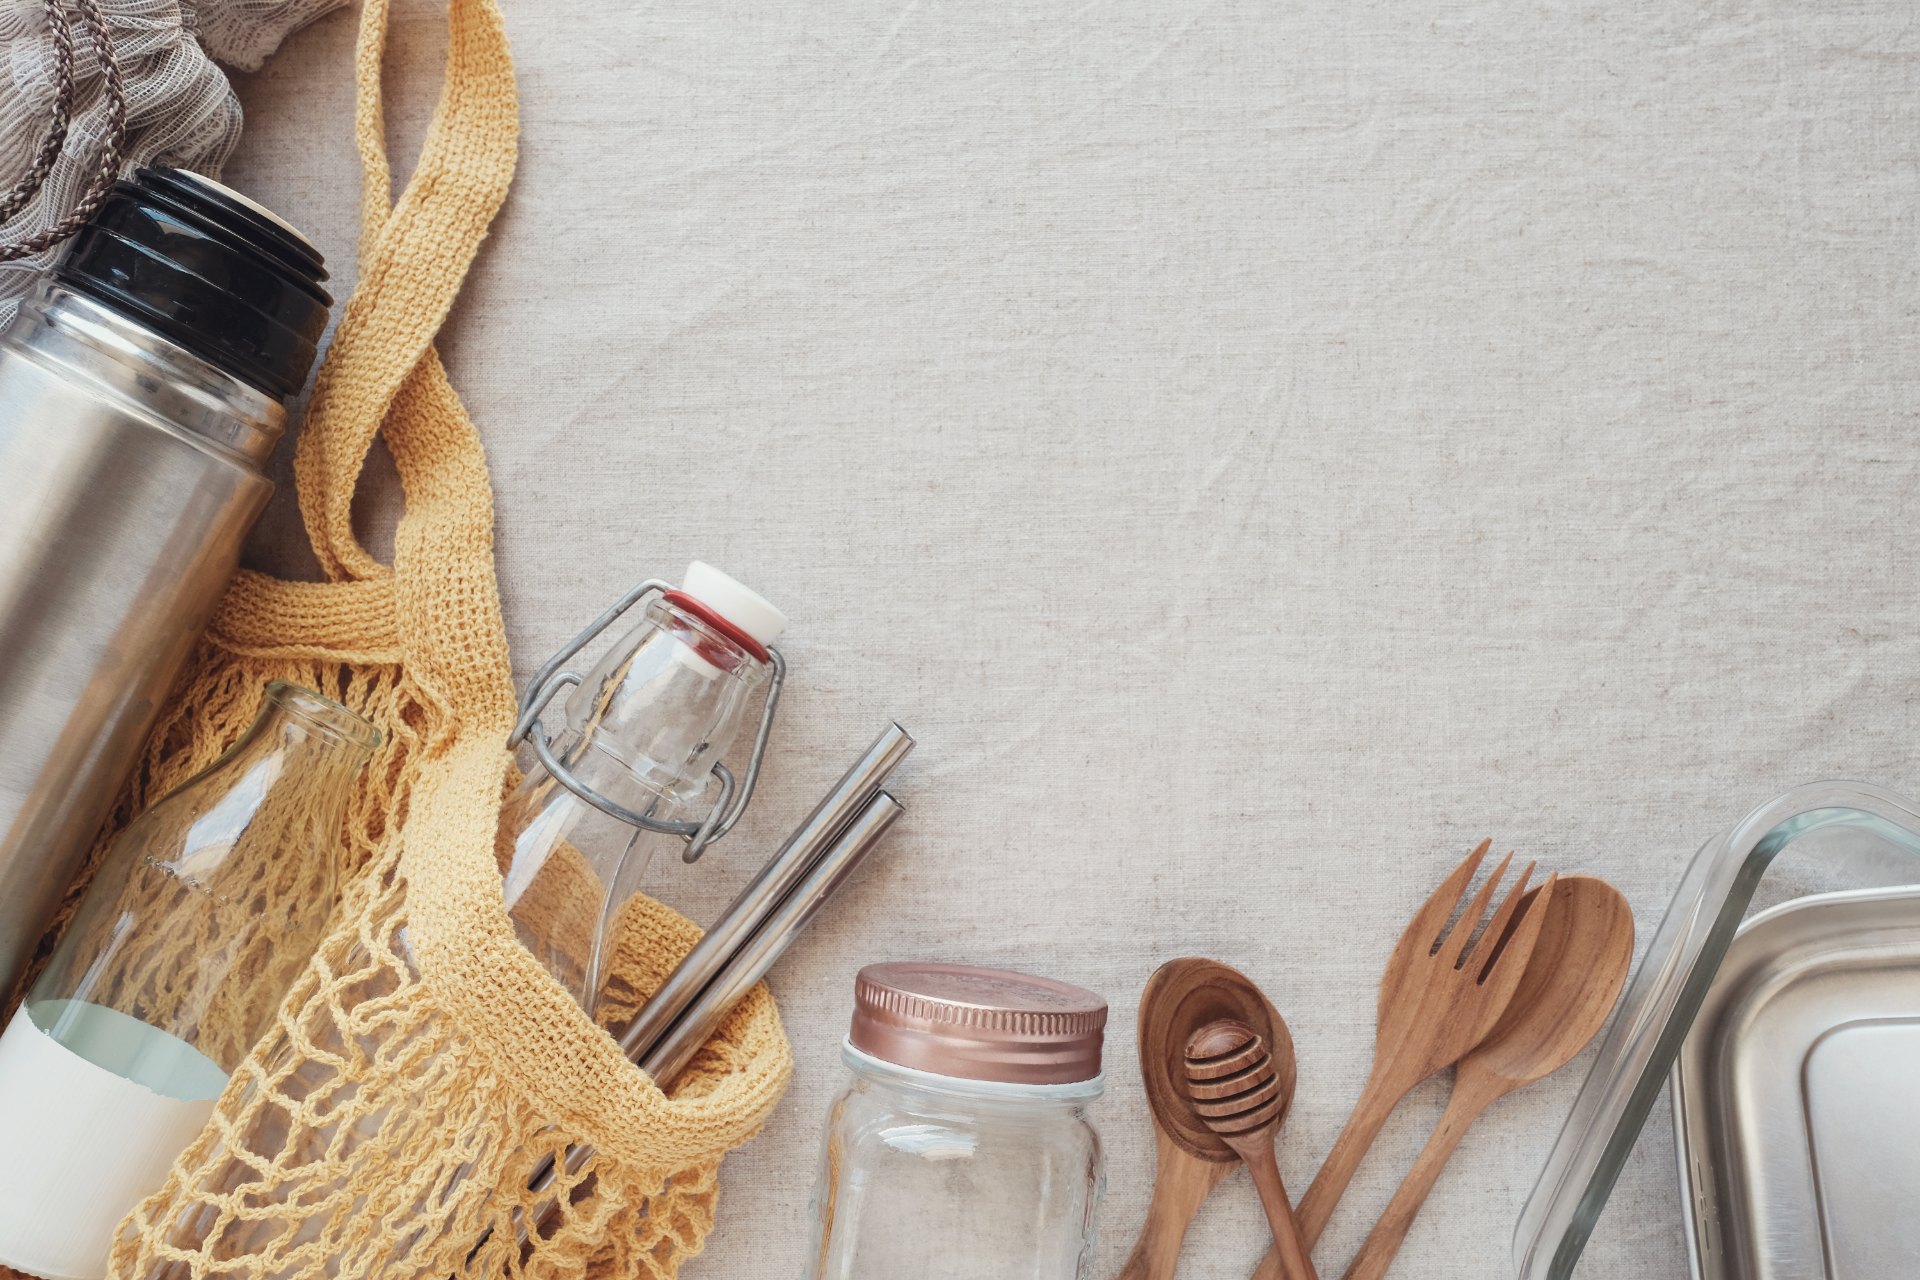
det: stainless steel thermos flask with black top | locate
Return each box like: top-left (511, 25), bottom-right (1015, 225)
top-left (0, 169), bottom-right (332, 996)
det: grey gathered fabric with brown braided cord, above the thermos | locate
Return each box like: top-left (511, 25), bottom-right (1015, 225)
top-left (0, 0), bottom-right (346, 324)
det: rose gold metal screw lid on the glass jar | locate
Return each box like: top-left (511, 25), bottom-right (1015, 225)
top-left (847, 963), bottom-right (1106, 1084)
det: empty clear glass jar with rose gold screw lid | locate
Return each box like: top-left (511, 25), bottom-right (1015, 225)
top-left (808, 963), bottom-right (1106, 1280)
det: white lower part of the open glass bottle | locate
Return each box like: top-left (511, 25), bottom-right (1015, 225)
top-left (0, 1002), bottom-right (227, 1280)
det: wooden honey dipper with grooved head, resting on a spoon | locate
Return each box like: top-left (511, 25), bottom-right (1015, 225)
top-left (1187, 1019), bottom-right (1319, 1280)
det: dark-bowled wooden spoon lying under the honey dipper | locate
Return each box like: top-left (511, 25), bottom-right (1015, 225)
top-left (1119, 958), bottom-right (1294, 1280)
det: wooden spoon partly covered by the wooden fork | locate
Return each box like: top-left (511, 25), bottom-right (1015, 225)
top-left (1346, 875), bottom-right (1634, 1280)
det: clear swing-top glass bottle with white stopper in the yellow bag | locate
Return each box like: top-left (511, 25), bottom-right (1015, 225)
top-left (499, 560), bottom-right (787, 1015)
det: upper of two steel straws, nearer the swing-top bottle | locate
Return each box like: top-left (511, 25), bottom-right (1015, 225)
top-left (614, 723), bottom-right (914, 1059)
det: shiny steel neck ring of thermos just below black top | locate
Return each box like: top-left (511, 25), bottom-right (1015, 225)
top-left (0, 276), bottom-right (286, 470)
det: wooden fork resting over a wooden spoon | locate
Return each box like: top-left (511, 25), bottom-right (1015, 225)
top-left (1254, 841), bottom-right (1553, 1280)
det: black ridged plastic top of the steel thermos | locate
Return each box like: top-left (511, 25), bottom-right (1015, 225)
top-left (54, 167), bottom-right (334, 399)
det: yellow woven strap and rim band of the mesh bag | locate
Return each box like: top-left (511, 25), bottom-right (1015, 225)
top-left (278, 0), bottom-right (791, 1186)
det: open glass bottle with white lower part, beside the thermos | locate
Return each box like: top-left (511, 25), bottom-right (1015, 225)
top-left (0, 681), bottom-right (380, 1280)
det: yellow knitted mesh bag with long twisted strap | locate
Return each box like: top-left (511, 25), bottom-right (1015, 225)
top-left (5, 0), bottom-right (791, 1280)
